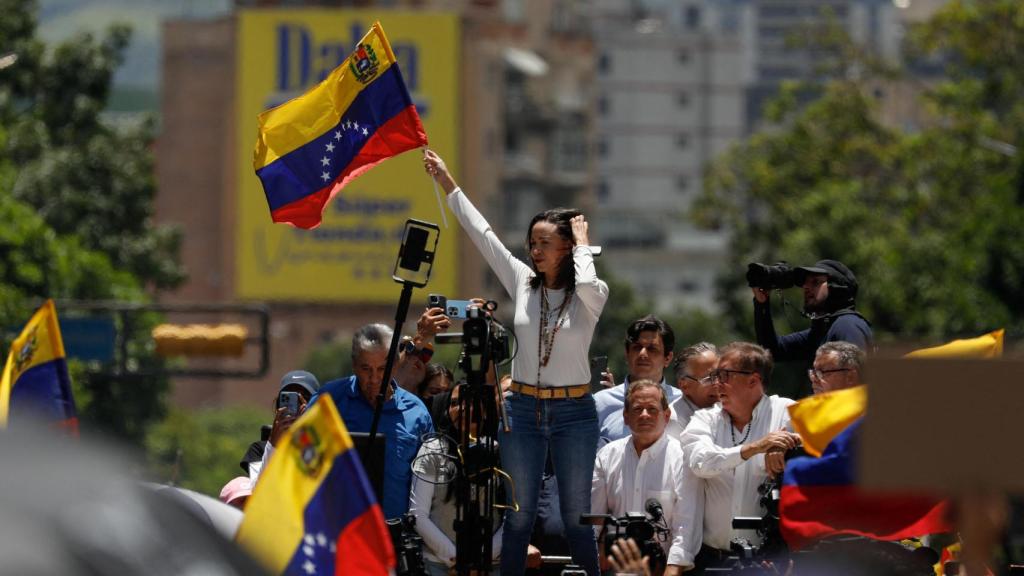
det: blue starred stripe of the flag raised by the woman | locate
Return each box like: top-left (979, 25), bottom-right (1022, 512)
top-left (256, 65), bottom-right (413, 212)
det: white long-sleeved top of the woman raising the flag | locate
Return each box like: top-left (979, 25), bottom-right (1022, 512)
top-left (447, 189), bottom-right (608, 386)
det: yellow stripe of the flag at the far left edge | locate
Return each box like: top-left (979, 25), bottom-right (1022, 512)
top-left (0, 300), bottom-right (65, 427)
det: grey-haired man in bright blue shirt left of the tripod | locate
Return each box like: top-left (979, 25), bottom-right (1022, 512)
top-left (310, 324), bottom-right (434, 519)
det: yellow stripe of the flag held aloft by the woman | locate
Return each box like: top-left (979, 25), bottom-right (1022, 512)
top-left (253, 22), bottom-right (395, 170)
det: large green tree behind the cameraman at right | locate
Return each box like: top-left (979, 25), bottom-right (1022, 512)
top-left (694, 1), bottom-right (1024, 338)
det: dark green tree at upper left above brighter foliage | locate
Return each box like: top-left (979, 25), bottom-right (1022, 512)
top-left (0, 0), bottom-right (184, 289)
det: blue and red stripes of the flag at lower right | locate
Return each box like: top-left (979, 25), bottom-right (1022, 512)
top-left (779, 419), bottom-right (951, 549)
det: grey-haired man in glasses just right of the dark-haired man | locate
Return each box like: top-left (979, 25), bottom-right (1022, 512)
top-left (666, 342), bottom-right (718, 438)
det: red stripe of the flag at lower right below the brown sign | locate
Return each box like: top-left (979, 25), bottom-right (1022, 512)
top-left (779, 486), bottom-right (952, 549)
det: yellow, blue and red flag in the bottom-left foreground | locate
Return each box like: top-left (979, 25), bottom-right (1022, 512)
top-left (237, 396), bottom-right (394, 576)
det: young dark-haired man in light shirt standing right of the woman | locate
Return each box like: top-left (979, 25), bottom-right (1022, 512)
top-left (594, 316), bottom-right (680, 446)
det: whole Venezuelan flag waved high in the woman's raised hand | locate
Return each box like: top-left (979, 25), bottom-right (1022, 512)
top-left (260, 23), bottom-right (427, 229)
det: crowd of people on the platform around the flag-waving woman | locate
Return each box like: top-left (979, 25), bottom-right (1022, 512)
top-left (214, 151), bottom-right (871, 576)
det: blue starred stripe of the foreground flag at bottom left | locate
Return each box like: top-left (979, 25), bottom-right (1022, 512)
top-left (284, 448), bottom-right (376, 576)
